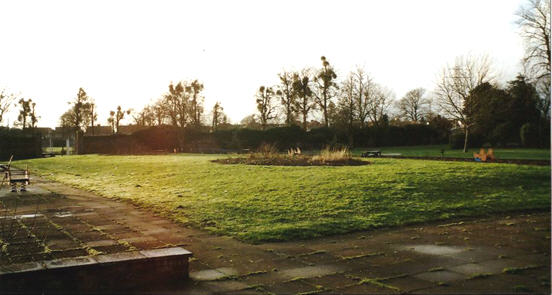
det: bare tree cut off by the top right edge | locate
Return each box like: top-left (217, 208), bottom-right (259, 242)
top-left (516, 0), bottom-right (551, 119)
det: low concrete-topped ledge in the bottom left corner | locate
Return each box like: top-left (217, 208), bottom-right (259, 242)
top-left (0, 247), bottom-right (192, 293)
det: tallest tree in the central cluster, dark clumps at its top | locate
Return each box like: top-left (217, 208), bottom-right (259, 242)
top-left (313, 56), bottom-right (337, 127)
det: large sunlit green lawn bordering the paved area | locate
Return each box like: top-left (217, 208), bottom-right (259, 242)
top-left (15, 154), bottom-right (550, 242)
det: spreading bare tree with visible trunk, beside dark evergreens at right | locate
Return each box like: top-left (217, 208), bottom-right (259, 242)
top-left (435, 56), bottom-right (494, 152)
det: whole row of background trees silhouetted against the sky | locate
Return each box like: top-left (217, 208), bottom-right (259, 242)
top-left (0, 0), bottom-right (551, 151)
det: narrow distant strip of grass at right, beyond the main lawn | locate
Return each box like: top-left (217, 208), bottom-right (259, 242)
top-left (353, 145), bottom-right (550, 160)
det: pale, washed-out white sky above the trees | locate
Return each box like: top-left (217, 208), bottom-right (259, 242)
top-left (0, 0), bottom-right (525, 127)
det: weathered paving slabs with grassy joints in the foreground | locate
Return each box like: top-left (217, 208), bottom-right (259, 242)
top-left (0, 178), bottom-right (550, 294)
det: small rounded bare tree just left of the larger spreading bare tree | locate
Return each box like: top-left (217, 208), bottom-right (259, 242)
top-left (397, 88), bottom-right (431, 122)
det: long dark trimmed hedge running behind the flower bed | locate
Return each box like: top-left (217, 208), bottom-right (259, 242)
top-left (83, 124), bottom-right (448, 154)
